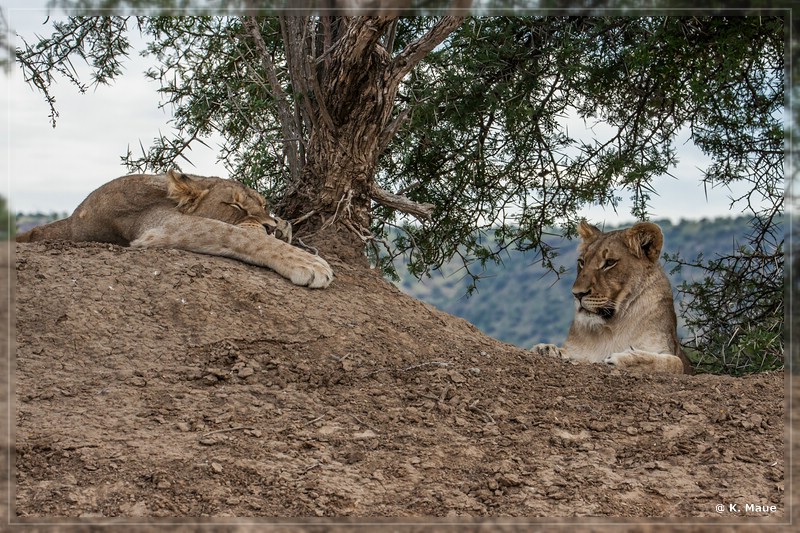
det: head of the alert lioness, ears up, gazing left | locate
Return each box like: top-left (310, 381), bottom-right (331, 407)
top-left (572, 221), bottom-right (664, 326)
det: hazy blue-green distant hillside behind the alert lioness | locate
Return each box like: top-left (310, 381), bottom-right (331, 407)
top-left (397, 217), bottom-right (764, 348)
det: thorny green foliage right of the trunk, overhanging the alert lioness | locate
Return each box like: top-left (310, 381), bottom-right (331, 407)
top-left (378, 17), bottom-right (784, 282)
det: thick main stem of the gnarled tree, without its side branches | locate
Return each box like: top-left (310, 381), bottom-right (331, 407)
top-left (280, 17), bottom-right (397, 265)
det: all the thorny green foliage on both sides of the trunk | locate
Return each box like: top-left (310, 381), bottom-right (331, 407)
top-left (17, 14), bottom-right (786, 374)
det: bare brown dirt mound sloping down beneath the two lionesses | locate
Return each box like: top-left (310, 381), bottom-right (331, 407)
top-left (12, 243), bottom-right (789, 523)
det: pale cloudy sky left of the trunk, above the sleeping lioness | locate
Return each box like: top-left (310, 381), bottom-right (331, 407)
top-left (0, 9), bottom-right (222, 212)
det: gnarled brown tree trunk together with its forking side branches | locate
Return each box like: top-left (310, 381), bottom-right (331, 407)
top-left (245, 16), bottom-right (462, 266)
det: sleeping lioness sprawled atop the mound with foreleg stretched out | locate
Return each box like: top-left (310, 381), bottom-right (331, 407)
top-left (16, 170), bottom-right (333, 288)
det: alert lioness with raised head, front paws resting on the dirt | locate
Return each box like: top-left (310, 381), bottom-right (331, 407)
top-left (533, 222), bottom-right (691, 374)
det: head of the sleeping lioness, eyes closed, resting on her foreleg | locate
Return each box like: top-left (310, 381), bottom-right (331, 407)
top-left (167, 170), bottom-right (292, 243)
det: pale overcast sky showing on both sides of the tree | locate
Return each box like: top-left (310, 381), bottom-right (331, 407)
top-left (0, 0), bottom-right (768, 225)
